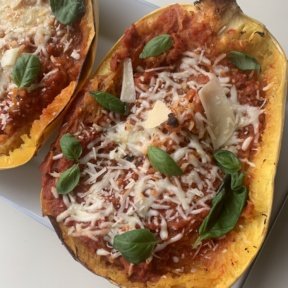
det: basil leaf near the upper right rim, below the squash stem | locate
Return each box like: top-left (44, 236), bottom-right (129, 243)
top-left (228, 51), bottom-right (261, 72)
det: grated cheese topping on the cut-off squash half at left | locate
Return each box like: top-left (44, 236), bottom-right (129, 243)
top-left (0, 0), bottom-right (80, 137)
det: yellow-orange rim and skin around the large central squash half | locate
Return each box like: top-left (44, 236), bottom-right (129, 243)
top-left (42, 0), bottom-right (287, 288)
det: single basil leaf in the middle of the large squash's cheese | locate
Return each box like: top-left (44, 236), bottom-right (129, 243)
top-left (147, 146), bottom-right (183, 176)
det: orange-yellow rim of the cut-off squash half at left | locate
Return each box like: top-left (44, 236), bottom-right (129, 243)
top-left (0, 0), bottom-right (99, 170)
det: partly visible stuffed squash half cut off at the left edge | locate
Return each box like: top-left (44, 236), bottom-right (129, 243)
top-left (0, 0), bottom-right (97, 169)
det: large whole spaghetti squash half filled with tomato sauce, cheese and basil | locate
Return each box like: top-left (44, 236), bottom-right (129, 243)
top-left (41, 0), bottom-right (286, 288)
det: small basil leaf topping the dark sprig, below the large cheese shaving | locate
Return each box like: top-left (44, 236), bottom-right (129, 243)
top-left (213, 150), bottom-right (241, 174)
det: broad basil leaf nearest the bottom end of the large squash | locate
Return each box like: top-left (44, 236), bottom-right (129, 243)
top-left (113, 229), bottom-right (157, 264)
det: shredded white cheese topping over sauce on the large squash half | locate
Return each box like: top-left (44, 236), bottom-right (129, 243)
top-left (51, 49), bottom-right (265, 261)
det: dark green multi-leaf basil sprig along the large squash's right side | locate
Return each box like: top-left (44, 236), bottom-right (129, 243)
top-left (193, 150), bottom-right (248, 247)
